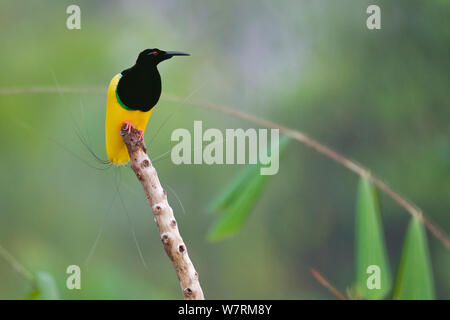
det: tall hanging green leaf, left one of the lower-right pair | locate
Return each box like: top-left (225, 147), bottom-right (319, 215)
top-left (355, 177), bottom-right (392, 299)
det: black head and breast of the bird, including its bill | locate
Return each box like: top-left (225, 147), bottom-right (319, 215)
top-left (117, 48), bottom-right (189, 112)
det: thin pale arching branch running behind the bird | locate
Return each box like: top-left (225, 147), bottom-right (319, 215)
top-left (0, 86), bottom-right (450, 249)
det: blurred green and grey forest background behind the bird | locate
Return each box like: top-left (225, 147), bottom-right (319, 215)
top-left (0, 0), bottom-right (450, 299)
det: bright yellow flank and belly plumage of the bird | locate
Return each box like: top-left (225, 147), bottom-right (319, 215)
top-left (105, 73), bottom-right (153, 165)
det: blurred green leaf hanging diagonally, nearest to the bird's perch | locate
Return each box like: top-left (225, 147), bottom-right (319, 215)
top-left (207, 136), bottom-right (289, 241)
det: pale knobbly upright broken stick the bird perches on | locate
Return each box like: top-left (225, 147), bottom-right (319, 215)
top-left (120, 126), bottom-right (205, 300)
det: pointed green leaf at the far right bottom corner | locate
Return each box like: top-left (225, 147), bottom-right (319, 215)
top-left (393, 218), bottom-right (435, 300)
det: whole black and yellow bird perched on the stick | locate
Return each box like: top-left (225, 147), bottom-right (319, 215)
top-left (105, 48), bottom-right (189, 165)
